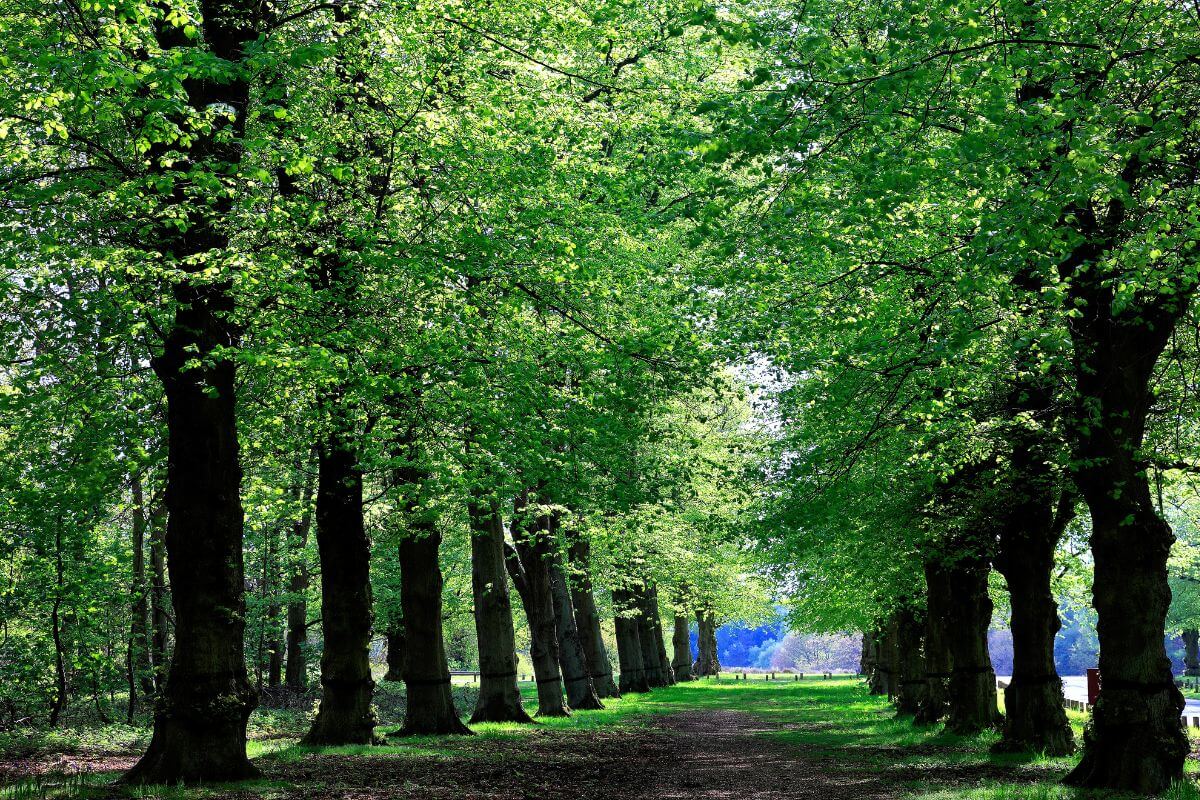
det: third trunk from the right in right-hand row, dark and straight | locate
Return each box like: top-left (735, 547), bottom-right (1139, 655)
top-left (946, 547), bottom-right (1001, 734)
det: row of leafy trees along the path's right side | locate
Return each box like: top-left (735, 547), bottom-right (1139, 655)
top-left (713, 0), bottom-right (1200, 792)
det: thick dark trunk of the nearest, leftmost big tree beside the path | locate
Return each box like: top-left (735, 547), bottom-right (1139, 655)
top-left (125, 298), bottom-right (258, 783)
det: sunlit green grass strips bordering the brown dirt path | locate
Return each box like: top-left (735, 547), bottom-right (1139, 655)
top-left (7, 678), bottom-right (1200, 800)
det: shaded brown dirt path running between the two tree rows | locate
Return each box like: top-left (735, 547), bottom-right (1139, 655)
top-left (262, 711), bottom-right (896, 800)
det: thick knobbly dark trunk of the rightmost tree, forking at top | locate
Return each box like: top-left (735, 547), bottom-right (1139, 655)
top-left (1067, 267), bottom-right (1189, 794)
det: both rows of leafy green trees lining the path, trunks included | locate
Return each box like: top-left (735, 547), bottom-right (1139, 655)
top-left (0, 0), bottom-right (1200, 790)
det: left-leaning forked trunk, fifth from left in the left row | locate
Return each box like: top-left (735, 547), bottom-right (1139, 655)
top-left (504, 495), bottom-right (570, 716)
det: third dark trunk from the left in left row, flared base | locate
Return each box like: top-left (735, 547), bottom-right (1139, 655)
top-left (392, 450), bottom-right (472, 736)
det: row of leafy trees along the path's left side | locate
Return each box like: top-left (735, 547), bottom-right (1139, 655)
top-left (0, 0), bottom-right (763, 782)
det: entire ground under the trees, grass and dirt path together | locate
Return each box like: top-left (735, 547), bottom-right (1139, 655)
top-left (0, 678), bottom-right (1200, 800)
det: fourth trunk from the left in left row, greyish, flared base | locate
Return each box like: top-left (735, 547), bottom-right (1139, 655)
top-left (467, 493), bottom-right (533, 723)
